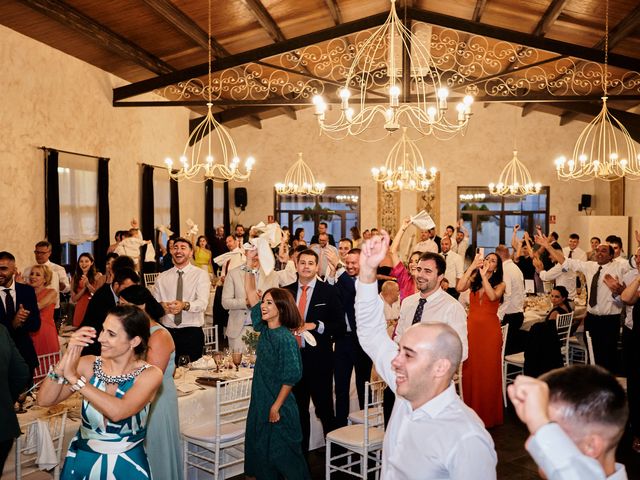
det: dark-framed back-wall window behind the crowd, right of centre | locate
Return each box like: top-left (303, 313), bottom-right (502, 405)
top-left (458, 187), bottom-right (549, 255)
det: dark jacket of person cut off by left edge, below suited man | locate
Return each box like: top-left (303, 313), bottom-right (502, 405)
top-left (0, 325), bottom-right (31, 442)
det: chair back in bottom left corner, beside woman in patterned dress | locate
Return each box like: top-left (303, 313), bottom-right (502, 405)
top-left (15, 408), bottom-right (67, 480)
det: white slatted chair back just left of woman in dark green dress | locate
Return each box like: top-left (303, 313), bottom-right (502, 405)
top-left (216, 377), bottom-right (253, 441)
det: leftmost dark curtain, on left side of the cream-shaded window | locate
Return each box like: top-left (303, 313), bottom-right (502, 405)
top-left (44, 150), bottom-right (61, 264)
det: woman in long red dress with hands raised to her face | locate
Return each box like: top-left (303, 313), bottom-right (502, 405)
top-left (457, 253), bottom-right (505, 428)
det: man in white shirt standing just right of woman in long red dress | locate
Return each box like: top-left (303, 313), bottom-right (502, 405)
top-left (496, 245), bottom-right (525, 354)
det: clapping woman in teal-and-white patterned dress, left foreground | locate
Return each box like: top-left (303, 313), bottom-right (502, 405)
top-left (38, 306), bottom-right (162, 480)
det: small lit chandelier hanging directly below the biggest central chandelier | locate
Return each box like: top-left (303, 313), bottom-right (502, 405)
top-left (371, 127), bottom-right (438, 192)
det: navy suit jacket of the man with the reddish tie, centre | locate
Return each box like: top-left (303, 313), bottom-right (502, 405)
top-left (285, 280), bottom-right (346, 360)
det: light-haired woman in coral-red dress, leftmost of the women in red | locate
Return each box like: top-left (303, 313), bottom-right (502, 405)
top-left (29, 265), bottom-right (60, 355)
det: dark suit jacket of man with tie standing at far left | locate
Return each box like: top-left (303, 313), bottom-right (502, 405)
top-left (0, 283), bottom-right (40, 369)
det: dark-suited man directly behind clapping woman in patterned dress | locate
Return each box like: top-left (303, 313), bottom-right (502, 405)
top-left (81, 267), bottom-right (140, 356)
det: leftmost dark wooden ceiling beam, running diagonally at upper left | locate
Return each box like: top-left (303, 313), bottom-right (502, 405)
top-left (20, 0), bottom-right (175, 75)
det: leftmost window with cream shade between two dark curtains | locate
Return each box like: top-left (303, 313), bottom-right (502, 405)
top-left (58, 152), bottom-right (98, 265)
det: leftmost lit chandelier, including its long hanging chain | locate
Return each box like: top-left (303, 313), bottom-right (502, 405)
top-left (165, 0), bottom-right (255, 182)
